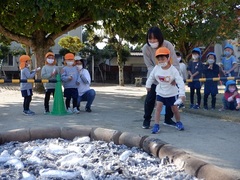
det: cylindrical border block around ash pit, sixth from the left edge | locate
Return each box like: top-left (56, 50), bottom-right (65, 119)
top-left (142, 137), bottom-right (167, 156)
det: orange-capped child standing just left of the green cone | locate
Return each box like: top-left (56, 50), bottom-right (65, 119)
top-left (41, 52), bottom-right (58, 114)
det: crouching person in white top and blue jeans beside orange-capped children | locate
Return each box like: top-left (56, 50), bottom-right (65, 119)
top-left (75, 56), bottom-right (96, 112)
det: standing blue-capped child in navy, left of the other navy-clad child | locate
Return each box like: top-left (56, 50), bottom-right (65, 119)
top-left (187, 48), bottom-right (203, 109)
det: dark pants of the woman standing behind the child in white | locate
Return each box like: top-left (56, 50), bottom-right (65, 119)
top-left (143, 84), bottom-right (173, 125)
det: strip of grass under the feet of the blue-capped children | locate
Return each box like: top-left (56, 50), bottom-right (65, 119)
top-left (141, 86), bottom-right (240, 123)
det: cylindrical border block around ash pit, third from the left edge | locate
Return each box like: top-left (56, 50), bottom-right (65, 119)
top-left (61, 126), bottom-right (92, 140)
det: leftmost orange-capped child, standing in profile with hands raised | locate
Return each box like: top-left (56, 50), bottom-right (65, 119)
top-left (19, 55), bottom-right (40, 116)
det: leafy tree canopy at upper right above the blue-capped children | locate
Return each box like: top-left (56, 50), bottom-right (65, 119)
top-left (155, 0), bottom-right (240, 60)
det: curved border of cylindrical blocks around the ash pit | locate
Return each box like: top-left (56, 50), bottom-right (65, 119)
top-left (0, 126), bottom-right (237, 180)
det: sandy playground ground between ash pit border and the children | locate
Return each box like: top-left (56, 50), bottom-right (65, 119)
top-left (0, 84), bottom-right (240, 177)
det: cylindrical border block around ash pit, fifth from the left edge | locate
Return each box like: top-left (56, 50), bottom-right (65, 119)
top-left (119, 132), bottom-right (148, 148)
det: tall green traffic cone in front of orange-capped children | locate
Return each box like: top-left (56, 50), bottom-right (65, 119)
top-left (51, 74), bottom-right (67, 115)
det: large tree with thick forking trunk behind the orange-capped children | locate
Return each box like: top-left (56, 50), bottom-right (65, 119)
top-left (0, 0), bottom-right (117, 77)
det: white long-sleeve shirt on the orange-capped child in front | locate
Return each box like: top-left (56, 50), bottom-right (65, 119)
top-left (146, 65), bottom-right (185, 97)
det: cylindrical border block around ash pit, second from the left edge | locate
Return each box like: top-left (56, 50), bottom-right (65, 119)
top-left (30, 127), bottom-right (61, 140)
